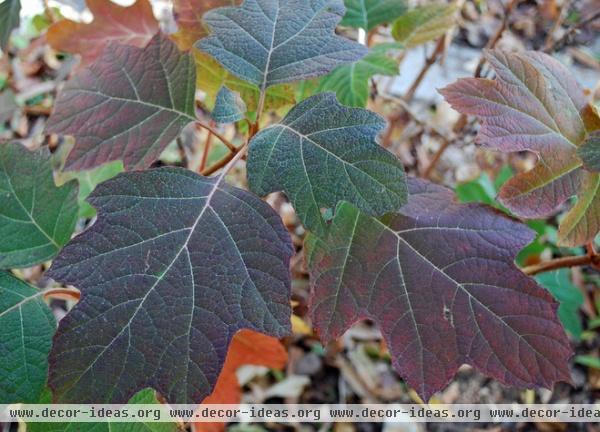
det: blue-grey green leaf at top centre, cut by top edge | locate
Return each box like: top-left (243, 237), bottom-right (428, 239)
top-left (196, 0), bottom-right (366, 90)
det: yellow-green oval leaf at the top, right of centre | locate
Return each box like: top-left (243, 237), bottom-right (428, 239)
top-left (392, 3), bottom-right (457, 48)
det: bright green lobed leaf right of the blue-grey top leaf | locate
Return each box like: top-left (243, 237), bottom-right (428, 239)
top-left (318, 44), bottom-right (398, 107)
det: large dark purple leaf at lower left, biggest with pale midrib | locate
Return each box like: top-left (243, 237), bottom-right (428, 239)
top-left (48, 168), bottom-right (293, 403)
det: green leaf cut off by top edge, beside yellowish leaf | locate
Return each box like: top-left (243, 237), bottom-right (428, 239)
top-left (340, 0), bottom-right (406, 31)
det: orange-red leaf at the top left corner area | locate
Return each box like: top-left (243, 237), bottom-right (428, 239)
top-left (47, 0), bottom-right (158, 65)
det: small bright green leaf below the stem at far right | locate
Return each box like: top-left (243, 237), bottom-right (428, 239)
top-left (535, 269), bottom-right (583, 340)
